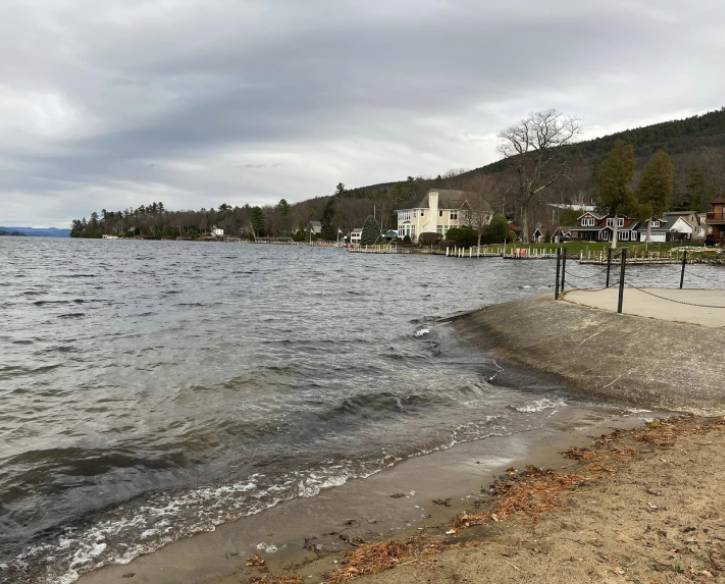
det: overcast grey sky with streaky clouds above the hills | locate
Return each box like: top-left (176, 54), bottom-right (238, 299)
top-left (0, 0), bottom-right (725, 227)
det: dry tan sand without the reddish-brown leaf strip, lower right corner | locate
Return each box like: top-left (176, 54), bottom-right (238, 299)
top-left (328, 418), bottom-right (725, 584)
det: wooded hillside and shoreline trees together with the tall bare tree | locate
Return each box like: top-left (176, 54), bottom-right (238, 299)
top-left (72, 108), bottom-right (725, 240)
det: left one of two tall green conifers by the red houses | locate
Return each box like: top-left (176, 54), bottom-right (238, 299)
top-left (597, 140), bottom-right (637, 248)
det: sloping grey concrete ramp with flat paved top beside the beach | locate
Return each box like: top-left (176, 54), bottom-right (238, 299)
top-left (454, 288), bottom-right (725, 415)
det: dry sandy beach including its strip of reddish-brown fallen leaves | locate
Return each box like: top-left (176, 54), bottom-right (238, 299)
top-left (223, 417), bottom-right (725, 584)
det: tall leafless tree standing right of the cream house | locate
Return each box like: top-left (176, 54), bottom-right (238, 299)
top-left (499, 109), bottom-right (581, 243)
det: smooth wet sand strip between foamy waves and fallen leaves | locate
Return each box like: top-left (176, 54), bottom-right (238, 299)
top-left (79, 407), bottom-right (651, 584)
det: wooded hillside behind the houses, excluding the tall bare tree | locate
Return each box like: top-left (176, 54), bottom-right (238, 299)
top-left (73, 108), bottom-right (725, 239)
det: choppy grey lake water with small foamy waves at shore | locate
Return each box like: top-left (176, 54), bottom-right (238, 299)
top-left (0, 238), bottom-right (720, 582)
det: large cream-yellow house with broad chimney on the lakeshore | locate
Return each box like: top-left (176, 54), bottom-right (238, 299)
top-left (396, 189), bottom-right (493, 242)
